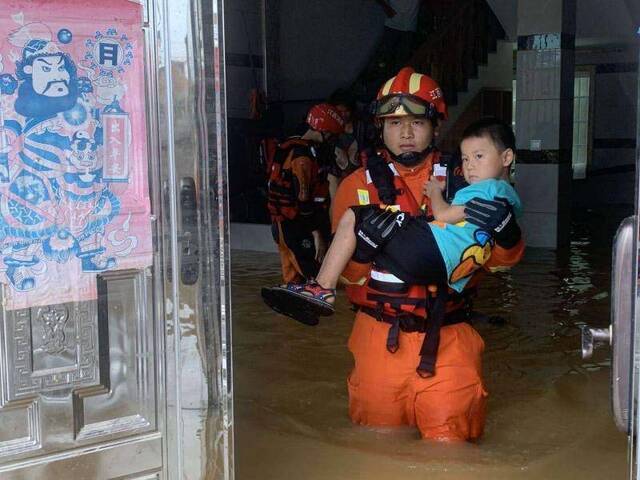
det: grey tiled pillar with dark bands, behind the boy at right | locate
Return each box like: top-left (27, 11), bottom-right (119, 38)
top-left (516, 0), bottom-right (576, 248)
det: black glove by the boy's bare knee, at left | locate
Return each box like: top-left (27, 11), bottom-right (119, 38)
top-left (351, 205), bottom-right (407, 263)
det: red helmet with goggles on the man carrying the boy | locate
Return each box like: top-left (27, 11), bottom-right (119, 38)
top-left (376, 67), bottom-right (448, 120)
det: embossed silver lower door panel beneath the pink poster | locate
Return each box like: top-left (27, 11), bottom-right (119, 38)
top-left (0, 270), bottom-right (159, 457)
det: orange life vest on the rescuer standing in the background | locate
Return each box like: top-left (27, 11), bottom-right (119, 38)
top-left (267, 138), bottom-right (329, 221)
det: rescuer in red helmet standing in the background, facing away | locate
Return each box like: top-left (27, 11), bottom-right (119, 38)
top-left (267, 103), bottom-right (344, 282)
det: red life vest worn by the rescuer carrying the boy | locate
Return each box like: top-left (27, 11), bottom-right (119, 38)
top-left (346, 151), bottom-right (452, 318)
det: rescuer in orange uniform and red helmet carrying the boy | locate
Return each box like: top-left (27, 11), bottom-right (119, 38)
top-left (332, 67), bottom-right (524, 440)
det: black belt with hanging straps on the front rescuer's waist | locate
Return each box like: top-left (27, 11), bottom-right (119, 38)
top-left (360, 289), bottom-right (470, 377)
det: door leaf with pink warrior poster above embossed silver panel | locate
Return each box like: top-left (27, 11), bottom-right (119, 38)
top-left (0, 0), bottom-right (159, 472)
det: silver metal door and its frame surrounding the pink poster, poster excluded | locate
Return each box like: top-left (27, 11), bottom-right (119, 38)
top-left (0, 0), bottom-right (233, 480)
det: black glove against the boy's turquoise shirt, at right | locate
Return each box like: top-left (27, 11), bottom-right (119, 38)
top-left (464, 197), bottom-right (522, 250)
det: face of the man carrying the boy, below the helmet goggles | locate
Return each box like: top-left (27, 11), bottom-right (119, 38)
top-left (382, 115), bottom-right (434, 155)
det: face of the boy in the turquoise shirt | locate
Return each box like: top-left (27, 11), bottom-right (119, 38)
top-left (460, 136), bottom-right (513, 184)
